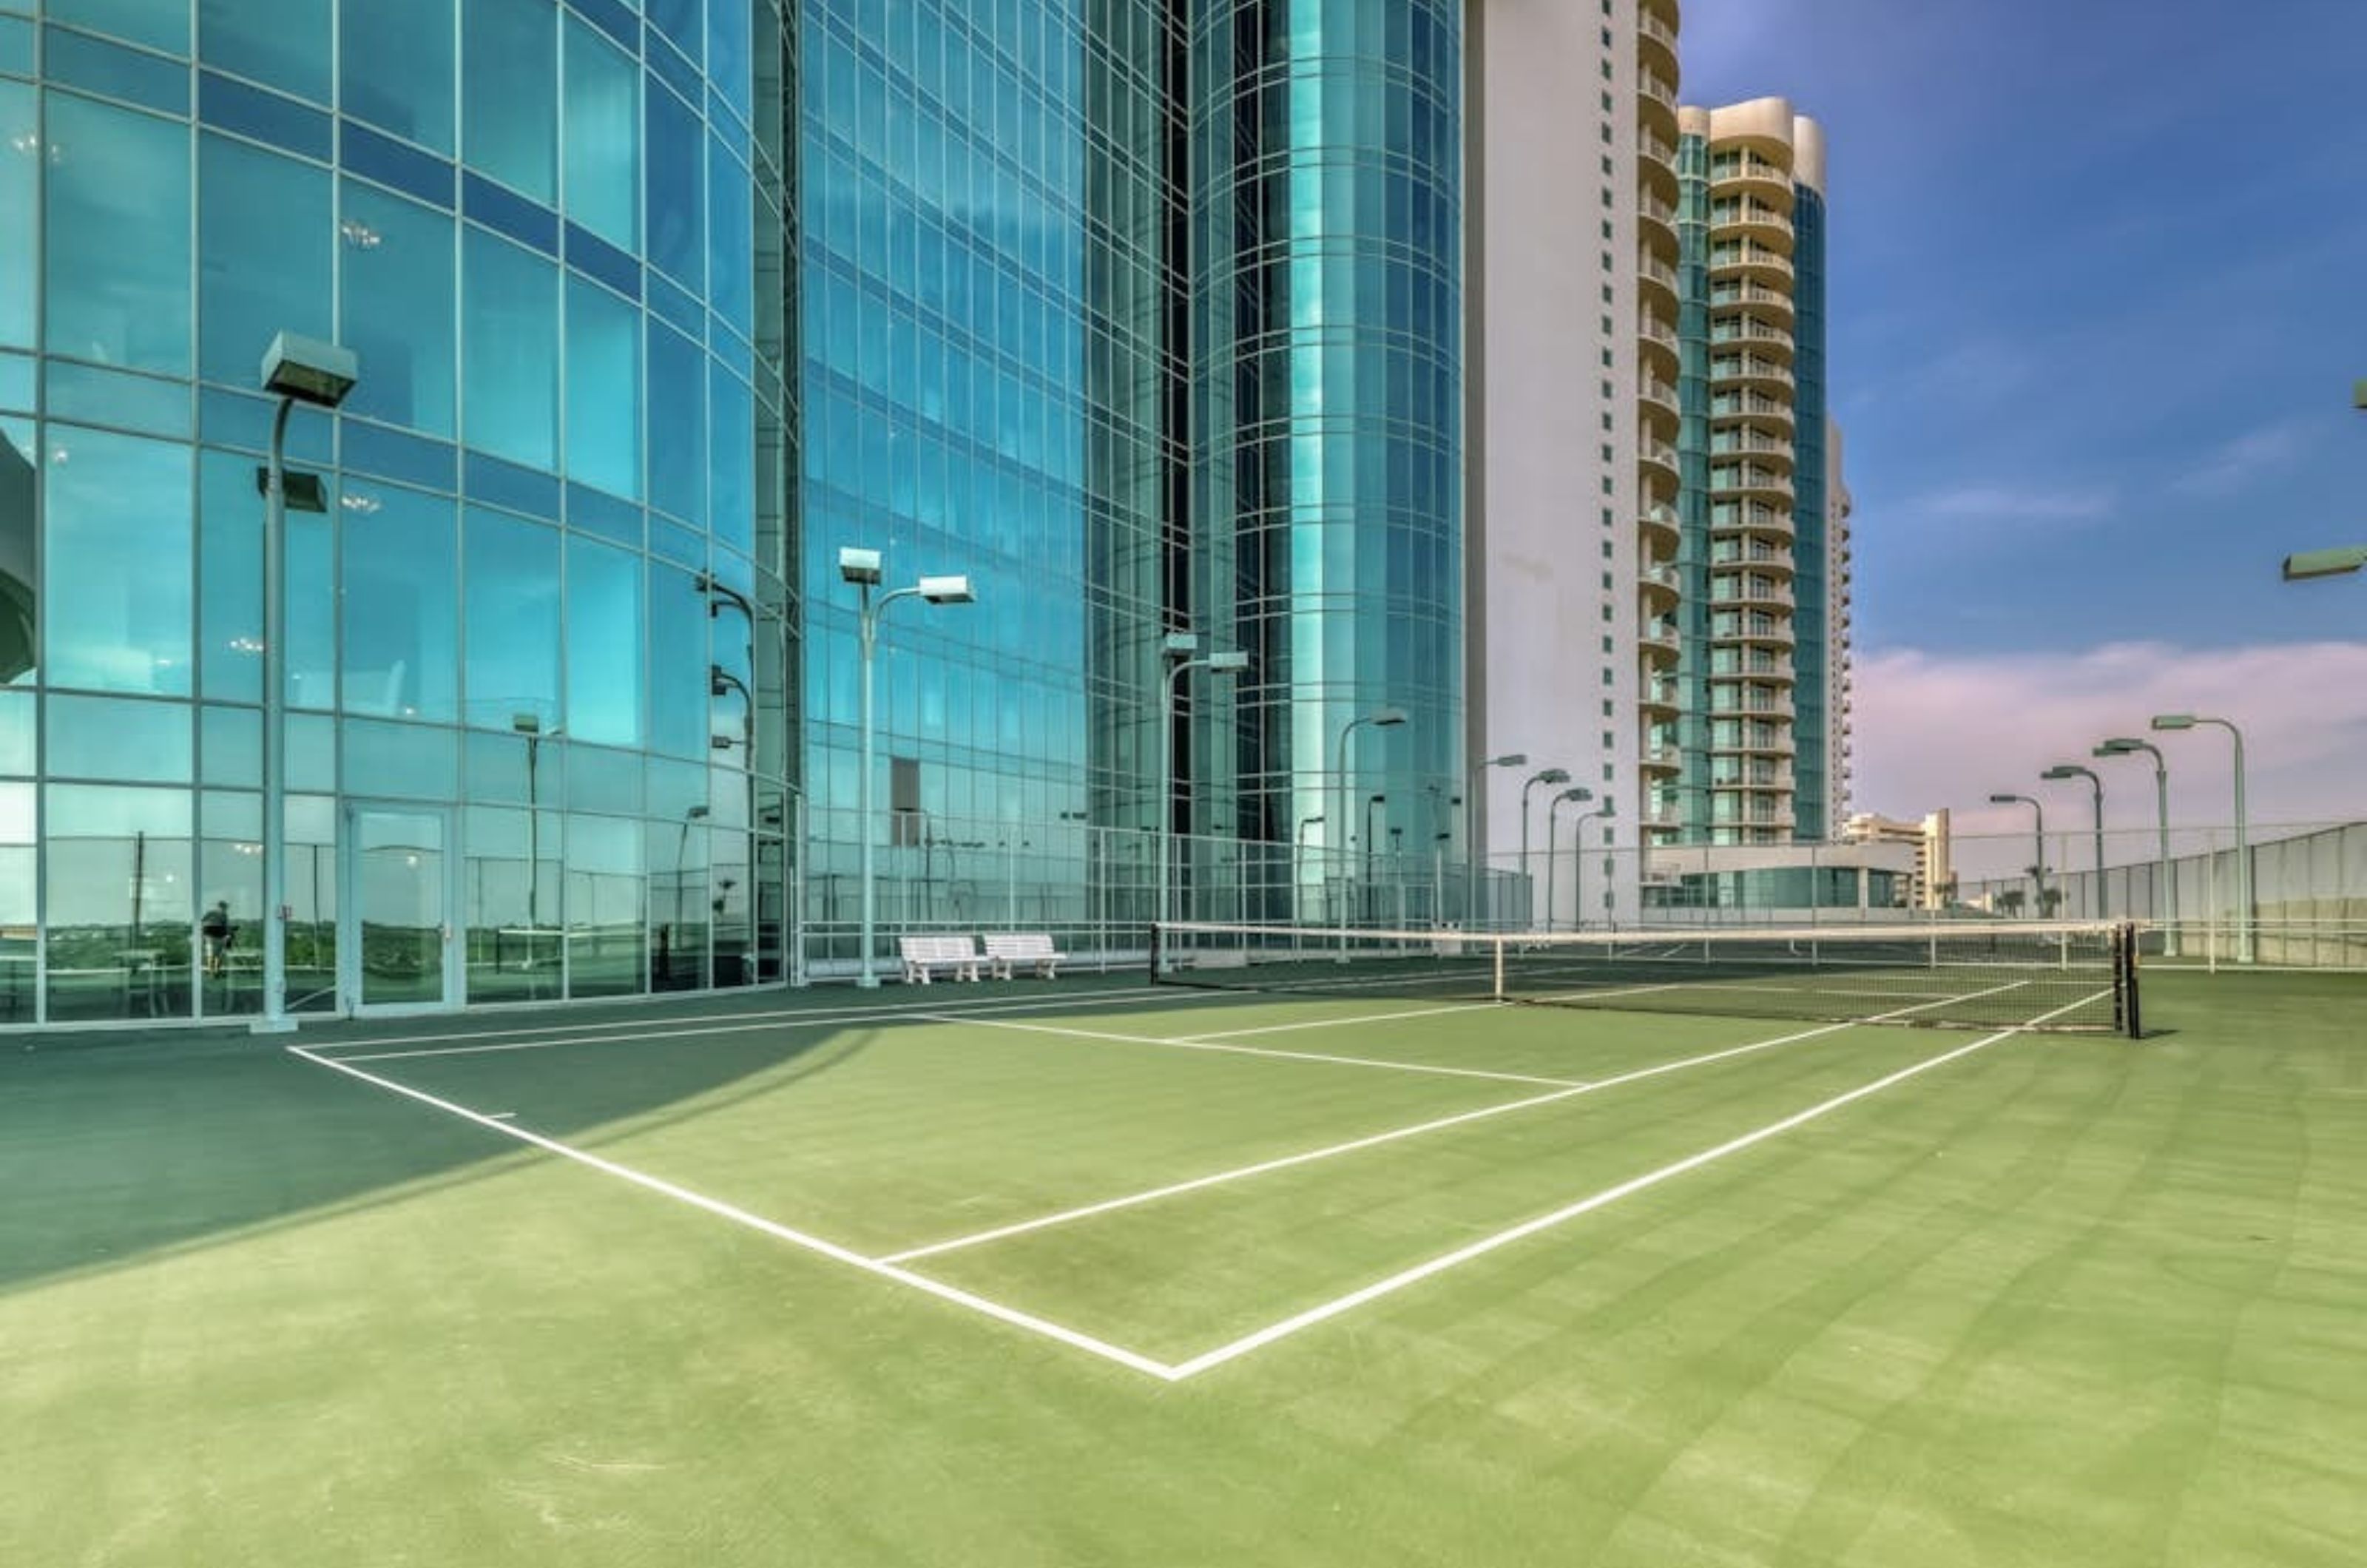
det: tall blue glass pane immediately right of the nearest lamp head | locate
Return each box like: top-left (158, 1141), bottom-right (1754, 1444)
top-left (339, 180), bottom-right (454, 442)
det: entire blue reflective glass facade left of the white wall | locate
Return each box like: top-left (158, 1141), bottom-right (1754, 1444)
top-left (0, 0), bottom-right (1463, 1026)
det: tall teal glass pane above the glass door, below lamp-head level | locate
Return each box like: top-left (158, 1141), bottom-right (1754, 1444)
top-left (341, 481), bottom-right (459, 720)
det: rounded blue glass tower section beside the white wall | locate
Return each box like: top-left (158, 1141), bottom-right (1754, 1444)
top-left (1188, 0), bottom-right (1463, 919)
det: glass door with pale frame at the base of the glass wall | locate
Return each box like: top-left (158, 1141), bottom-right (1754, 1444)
top-left (339, 800), bottom-right (462, 1014)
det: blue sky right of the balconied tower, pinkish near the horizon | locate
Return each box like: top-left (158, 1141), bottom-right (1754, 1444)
top-left (1683, 0), bottom-right (2367, 817)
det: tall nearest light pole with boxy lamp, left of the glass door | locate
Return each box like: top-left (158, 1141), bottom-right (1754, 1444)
top-left (251, 331), bottom-right (362, 1035)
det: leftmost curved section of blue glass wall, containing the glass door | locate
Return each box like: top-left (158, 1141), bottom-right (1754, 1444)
top-left (0, 0), bottom-right (797, 1023)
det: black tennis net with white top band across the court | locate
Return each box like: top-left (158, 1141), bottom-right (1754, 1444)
top-left (1152, 922), bottom-right (2138, 1035)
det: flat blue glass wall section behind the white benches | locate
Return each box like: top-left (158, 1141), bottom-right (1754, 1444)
top-left (797, 0), bottom-right (1179, 969)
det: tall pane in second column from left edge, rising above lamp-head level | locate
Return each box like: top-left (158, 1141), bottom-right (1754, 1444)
top-left (47, 92), bottom-right (189, 374)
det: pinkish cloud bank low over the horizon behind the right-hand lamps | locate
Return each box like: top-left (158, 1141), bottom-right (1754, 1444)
top-left (1856, 642), bottom-right (2367, 848)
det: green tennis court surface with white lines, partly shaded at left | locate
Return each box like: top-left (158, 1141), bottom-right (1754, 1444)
top-left (0, 971), bottom-right (2367, 1568)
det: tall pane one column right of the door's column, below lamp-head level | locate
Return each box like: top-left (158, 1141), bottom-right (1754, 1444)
top-left (464, 507), bottom-right (558, 732)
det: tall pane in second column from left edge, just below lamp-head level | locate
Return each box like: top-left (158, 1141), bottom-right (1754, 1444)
top-left (43, 424), bottom-right (194, 697)
